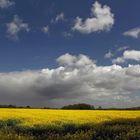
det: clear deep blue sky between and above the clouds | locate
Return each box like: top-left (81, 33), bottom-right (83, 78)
top-left (0, 0), bottom-right (140, 71)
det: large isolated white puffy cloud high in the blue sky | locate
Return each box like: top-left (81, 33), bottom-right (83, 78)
top-left (72, 1), bottom-right (114, 34)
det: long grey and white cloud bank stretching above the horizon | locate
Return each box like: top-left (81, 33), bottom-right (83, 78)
top-left (0, 53), bottom-right (140, 107)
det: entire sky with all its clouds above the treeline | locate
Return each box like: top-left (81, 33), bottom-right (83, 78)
top-left (0, 0), bottom-right (140, 107)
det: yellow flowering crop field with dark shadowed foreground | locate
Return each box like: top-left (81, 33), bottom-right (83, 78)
top-left (0, 109), bottom-right (140, 140)
